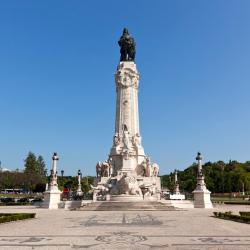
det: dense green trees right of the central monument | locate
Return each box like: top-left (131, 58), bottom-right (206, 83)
top-left (162, 160), bottom-right (250, 193)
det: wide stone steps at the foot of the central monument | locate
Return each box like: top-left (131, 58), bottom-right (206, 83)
top-left (78, 201), bottom-right (176, 211)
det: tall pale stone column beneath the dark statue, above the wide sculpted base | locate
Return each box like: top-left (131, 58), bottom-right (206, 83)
top-left (110, 61), bottom-right (145, 175)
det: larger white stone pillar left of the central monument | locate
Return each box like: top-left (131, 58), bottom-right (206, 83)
top-left (42, 153), bottom-right (62, 209)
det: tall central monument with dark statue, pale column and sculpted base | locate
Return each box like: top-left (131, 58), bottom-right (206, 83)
top-left (94, 28), bottom-right (161, 201)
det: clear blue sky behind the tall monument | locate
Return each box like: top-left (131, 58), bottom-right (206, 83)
top-left (0, 0), bottom-right (250, 175)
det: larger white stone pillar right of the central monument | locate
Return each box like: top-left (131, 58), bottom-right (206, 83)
top-left (193, 152), bottom-right (213, 208)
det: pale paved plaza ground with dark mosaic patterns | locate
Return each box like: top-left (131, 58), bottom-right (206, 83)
top-left (0, 205), bottom-right (250, 250)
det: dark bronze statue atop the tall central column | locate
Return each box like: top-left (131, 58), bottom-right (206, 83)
top-left (118, 28), bottom-right (135, 62)
